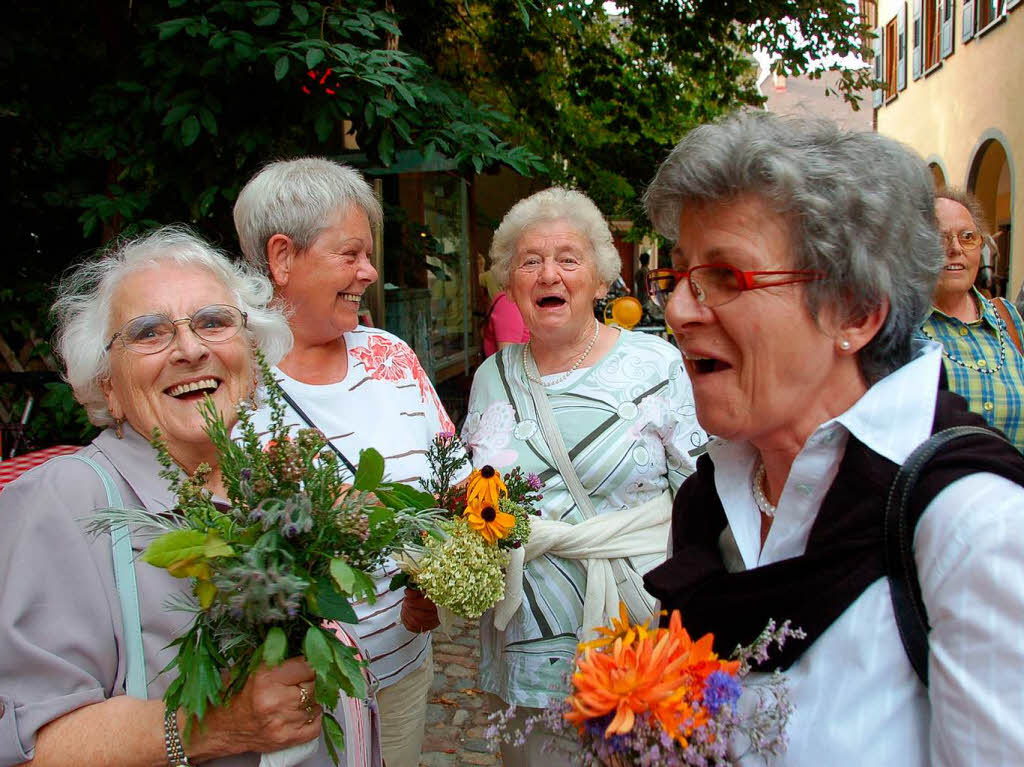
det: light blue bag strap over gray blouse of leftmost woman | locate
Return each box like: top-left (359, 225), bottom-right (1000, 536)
top-left (69, 455), bottom-right (147, 700)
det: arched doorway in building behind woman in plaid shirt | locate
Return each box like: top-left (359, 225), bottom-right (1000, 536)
top-left (967, 138), bottom-right (1013, 298)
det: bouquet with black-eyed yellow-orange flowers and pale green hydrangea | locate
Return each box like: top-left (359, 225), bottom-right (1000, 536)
top-left (392, 434), bottom-right (541, 619)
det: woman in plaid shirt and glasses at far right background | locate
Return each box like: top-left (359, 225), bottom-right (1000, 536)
top-left (922, 188), bottom-right (1024, 450)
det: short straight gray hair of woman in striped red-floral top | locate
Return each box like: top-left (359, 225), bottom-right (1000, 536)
top-left (234, 157), bottom-right (384, 273)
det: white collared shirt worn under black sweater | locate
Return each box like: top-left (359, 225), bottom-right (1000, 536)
top-left (709, 343), bottom-right (1024, 767)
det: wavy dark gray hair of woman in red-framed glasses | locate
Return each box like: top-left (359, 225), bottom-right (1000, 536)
top-left (644, 110), bottom-right (945, 385)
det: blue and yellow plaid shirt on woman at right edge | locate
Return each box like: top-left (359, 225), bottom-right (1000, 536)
top-left (921, 289), bottom-right (1024, 450)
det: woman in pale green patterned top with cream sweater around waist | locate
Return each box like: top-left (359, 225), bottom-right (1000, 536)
top-left (462, 187), bottom-right (706, 765)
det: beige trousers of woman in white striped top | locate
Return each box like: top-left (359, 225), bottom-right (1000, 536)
top-left (377, 646), bottom-right (434, 767)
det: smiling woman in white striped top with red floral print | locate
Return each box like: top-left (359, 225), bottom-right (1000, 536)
top-left (234, 158), bottom-right (468, 767)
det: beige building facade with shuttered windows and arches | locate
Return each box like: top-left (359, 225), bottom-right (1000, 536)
top-left (860, 0), bottom-right (1024, 299)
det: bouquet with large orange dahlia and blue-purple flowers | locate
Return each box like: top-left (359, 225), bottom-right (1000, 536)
top-left (488, 605), bottom-right (803, 767)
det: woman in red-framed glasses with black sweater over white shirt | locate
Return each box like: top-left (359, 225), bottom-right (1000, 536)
top-left (645, 112), bottom-right (1024, 767)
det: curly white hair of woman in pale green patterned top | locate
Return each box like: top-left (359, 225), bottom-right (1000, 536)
top-left (490, 186), bottom-right (623, 288)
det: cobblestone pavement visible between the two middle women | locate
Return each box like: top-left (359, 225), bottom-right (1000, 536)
top-left (420, 619), bottom-right (502, 767)
